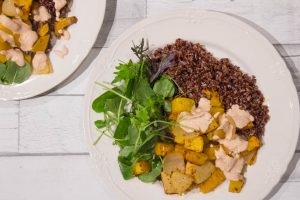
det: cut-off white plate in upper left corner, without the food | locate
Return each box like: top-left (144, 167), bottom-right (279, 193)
top-left (0, 0), bottom-right (106, 100)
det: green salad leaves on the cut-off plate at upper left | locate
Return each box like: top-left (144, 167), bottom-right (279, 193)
top-left (0, 61), bottom-right (32, 85)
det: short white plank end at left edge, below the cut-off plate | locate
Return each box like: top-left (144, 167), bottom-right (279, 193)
top-left (0, 101), bottom-right (19, 154)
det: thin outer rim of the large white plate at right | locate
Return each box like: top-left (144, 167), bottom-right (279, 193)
top-left (83, 8), bottom-right (300, 199)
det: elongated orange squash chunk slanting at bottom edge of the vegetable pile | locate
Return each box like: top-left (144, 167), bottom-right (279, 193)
top-left (200, 168), bottom-right (226, 193)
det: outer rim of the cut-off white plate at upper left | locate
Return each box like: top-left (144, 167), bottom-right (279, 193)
top-left (0, 0), bottom-right (107, 101)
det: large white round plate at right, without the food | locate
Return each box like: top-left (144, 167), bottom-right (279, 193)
top-left (84, 10), bottom-right (299, 200)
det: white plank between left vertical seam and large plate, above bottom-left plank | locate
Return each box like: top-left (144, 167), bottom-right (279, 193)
top-left (19, 96), bottom-right (87, 153)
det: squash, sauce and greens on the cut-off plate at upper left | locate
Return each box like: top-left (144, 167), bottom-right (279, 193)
top-left (0, 0), bottom-right (77, 85)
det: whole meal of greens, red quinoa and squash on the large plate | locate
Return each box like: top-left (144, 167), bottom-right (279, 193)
top-left (92, 39), bottom-right (269, 195)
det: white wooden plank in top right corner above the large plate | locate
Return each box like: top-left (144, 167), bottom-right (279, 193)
top-left (147, 0), bottom-right (300, 44)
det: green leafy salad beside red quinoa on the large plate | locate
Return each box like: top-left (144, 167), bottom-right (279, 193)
top-left (92, 40), bottom-right (177, 182)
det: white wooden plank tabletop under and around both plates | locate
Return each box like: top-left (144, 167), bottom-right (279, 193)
top-left (0, 0), bottom-right (300, 200)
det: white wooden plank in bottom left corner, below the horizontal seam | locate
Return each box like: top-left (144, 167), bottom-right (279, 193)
top-left (0, 156), bottom-right (109, 200)
